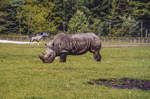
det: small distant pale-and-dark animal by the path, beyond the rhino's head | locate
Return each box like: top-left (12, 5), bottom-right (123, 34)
top-left (28, 32), bottom-right (50, 45)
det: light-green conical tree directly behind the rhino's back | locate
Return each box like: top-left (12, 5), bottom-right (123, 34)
top-left (68, 10), bottom-right (88, 33)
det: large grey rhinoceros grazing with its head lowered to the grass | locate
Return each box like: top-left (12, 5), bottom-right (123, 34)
top-left (39, 33), bottom-right (101, 63)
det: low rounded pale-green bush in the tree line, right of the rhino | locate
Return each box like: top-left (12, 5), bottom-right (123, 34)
top-left (109, 16), bottom-right (140, 36)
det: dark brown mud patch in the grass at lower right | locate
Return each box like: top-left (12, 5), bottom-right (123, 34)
top-left (88, 78), bottom-right (150, 90)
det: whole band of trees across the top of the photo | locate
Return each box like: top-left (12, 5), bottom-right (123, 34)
top-left (0, 0), bottom-right (150, 36)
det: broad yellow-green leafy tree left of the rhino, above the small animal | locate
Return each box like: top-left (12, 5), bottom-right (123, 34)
top-left (18, 0), bottom-right (57, 34)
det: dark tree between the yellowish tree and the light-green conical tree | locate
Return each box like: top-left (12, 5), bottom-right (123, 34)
top-left (54, 0), bottom-right (77, 32)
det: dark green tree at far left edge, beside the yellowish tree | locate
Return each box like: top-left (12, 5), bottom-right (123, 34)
top-left (0, 0), bottom-right (23, 33)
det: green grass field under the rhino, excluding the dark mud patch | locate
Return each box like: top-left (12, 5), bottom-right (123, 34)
top-left (0, 44), bottom-right (150, 99)
